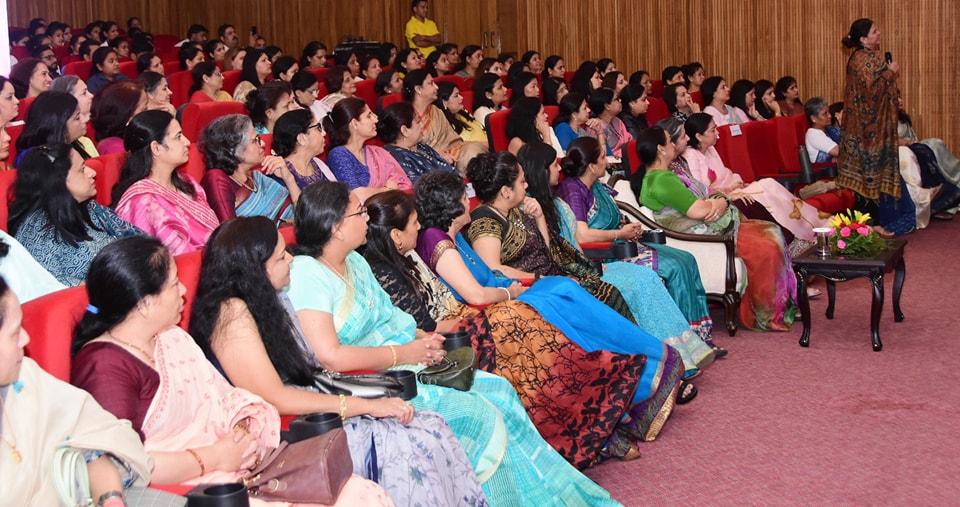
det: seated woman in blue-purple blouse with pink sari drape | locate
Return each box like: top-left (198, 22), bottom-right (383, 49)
top-left (323, 97), bottom-right (410, 190)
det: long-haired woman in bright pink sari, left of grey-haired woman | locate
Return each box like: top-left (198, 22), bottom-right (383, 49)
top-left (112, 111), bottom-right (220, 255)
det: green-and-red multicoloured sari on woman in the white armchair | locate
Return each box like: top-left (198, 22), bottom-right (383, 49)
top-left (639, 169), bottom-right (797, 331)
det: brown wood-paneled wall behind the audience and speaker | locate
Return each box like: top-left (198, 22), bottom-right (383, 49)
top-left (8, 0), bottom-right (960, 149)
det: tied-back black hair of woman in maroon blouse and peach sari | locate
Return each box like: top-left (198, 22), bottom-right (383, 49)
top-left (72, 236), bottom-right (173, 355)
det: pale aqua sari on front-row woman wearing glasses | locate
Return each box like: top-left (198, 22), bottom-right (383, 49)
top-left (287, 252), bottom-right (615, 506)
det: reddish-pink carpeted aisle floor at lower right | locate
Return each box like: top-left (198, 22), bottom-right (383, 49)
top-left (587, 218), bottom-right (960, 505)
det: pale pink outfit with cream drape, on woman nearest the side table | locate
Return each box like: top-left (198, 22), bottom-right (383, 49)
top-left (683, 146), bottom-right (828, 241)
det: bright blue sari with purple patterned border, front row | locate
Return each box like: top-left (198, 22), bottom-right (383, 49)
top-left (417, 228), bottom-right (683, 464)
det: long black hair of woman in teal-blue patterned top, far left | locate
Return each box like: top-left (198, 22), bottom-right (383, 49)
top-left (10, 143), bottom-right (99, 247)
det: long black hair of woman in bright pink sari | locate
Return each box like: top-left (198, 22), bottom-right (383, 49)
top-left (110, 109), bottom-right (196, 208)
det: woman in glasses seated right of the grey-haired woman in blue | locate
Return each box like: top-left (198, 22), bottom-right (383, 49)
top-left (273, 109), bottom-right (337, 189)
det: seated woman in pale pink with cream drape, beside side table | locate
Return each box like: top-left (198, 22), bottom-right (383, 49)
top-left (683, 113), bottom-right (828, 245)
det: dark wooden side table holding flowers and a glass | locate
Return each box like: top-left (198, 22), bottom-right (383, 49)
top-left (793, 239), bottom-right (907, 352)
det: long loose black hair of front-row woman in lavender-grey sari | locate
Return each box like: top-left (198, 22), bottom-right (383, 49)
top-left (190, 216), bottom-right (315, 386)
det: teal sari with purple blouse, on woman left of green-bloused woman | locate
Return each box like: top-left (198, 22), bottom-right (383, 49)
top-left (556, 178), bottom-right (713, 340)
